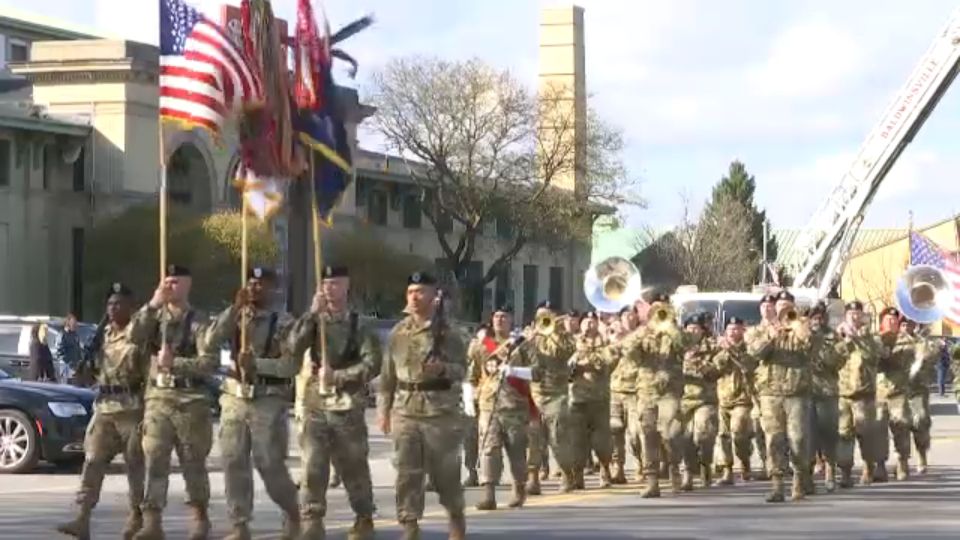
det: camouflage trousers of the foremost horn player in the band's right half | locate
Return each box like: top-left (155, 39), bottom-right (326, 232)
top-left (760, 396), bottom-right (810, 476)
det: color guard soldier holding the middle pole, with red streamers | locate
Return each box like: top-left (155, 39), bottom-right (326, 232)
top-left (208, 267), bottom-right (300, 540)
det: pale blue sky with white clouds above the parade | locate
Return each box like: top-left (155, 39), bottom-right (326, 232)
top-left (7, 0), bottom-right (960, 228)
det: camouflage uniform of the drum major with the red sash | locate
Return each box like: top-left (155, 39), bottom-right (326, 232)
top-left (469, 336), bottom-right (530, 510)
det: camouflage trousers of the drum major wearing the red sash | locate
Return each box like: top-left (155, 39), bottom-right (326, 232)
top-left (478, 410), bottom-right (530, 485)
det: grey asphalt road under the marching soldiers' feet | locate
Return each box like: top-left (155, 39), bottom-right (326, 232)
top-left (0, 398), bottom-right (960, 540)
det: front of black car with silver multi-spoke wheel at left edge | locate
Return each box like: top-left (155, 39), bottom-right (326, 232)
top-left (0, 370), bottom-right (96, 474)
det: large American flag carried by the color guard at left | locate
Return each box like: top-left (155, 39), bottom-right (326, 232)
top-left (160, 0), bottom-right (264, 134)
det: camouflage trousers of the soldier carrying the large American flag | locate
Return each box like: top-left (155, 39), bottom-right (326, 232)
top-left (143, 398), bottom-right (213, 510)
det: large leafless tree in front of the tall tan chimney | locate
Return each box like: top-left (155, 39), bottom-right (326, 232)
top-left (368, 57), bottom-right (642, 312)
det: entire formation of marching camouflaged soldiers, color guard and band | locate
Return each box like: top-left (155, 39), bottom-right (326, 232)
top-left (48, 258), bottom-right (960, 540)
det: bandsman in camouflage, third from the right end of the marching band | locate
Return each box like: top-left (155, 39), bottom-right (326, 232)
top-left (837, 300), bottom-right (882, 488)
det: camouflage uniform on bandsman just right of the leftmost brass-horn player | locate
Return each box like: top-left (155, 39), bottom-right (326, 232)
top-left (570, 335), bottom-right (619, 489)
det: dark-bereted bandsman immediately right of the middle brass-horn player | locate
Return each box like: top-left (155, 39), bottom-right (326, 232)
top-left (680, 313), bottom-right (721, 491)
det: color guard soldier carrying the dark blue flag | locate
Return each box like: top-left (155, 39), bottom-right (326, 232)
top-left (290, 266), bottom-right (381, 540)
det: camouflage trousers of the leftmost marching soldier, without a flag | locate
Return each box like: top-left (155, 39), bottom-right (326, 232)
top-left (77, 408), bottom-right (144, 509)
